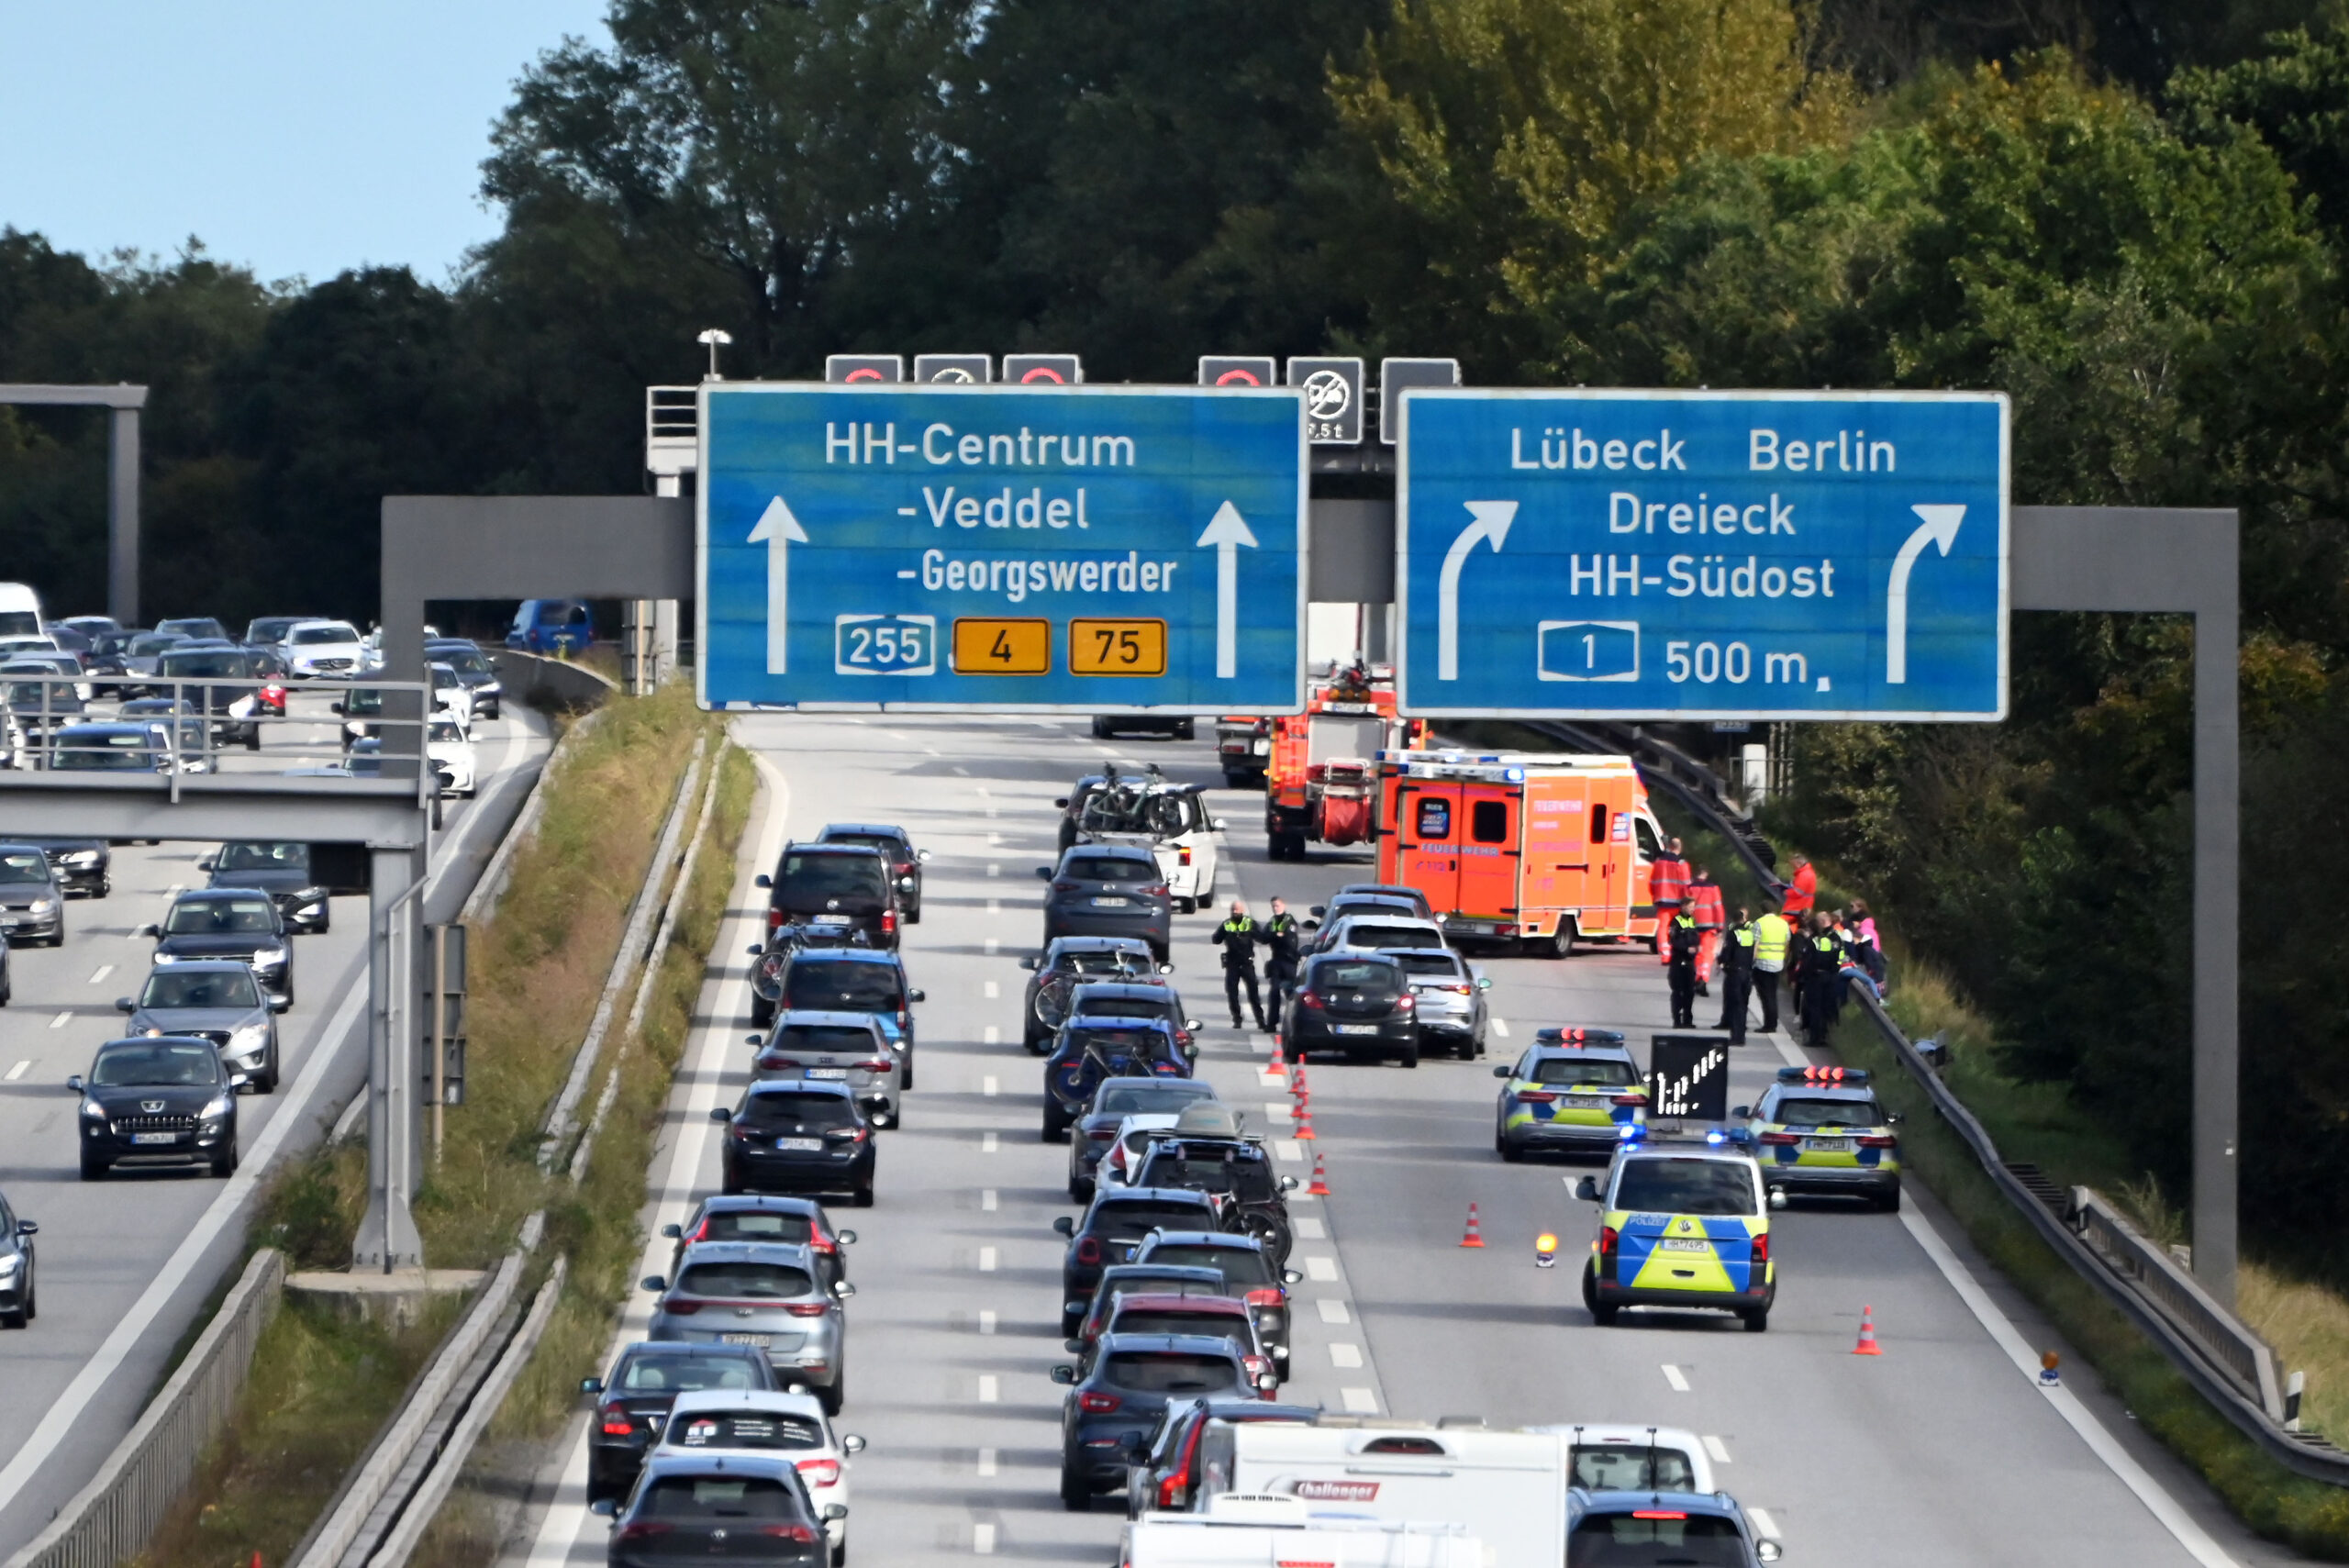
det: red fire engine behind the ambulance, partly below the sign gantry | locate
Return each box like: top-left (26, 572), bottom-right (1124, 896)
top-left (1264, 664), bottom-right (1428, 859)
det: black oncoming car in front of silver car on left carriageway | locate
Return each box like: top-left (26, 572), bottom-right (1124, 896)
top-left (66, 1035), bottom-right (244, 1181)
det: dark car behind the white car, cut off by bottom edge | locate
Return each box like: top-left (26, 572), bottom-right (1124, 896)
top-left (592, 1453), bottom-right (848, 1568)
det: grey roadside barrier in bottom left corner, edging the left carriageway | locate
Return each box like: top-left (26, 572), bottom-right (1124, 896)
top-left (5, 1249), bottom-right (286, 1568)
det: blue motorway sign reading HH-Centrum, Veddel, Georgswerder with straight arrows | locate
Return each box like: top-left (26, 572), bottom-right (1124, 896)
top-left (697, 383), bottom-right (1306, 714)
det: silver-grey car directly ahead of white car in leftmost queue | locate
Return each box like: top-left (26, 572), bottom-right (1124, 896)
top-left (643, 1241), bottom-right (857, 1416)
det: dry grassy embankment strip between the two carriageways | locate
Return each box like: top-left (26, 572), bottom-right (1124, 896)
top-left (141, 685), bottom-right (751, 1568)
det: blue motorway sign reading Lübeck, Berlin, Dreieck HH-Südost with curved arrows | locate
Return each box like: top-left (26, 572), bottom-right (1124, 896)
top-left (1396, 387), bottom-right (2006, 718)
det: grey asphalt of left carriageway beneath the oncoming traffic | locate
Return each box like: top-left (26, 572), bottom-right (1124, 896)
top-left (0, 705), bottom-right (547, 1556)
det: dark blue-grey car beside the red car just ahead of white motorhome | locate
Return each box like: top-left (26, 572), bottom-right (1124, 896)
top-left (1052, 1333), bottom-right (1278, 1512)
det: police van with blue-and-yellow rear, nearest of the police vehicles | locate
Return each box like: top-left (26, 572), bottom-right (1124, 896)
top-left (1576, 1129), bottom-right (1786, 1333)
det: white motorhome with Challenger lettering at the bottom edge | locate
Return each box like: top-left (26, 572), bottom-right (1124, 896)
top-left (1198, 1422), bottom-right (1569, 1568)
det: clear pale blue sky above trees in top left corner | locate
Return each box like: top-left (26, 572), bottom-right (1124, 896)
top-left (0, 0), bottom-right (608, 282)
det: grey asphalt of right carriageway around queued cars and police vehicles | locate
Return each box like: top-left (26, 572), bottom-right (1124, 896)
top-left (512, 716), bottom-right (2295, 1568)
